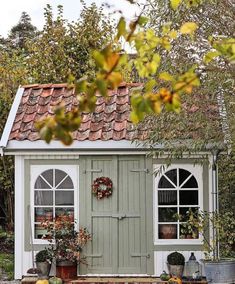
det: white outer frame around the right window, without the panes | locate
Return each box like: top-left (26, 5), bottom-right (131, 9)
top-left (153, 163), bottom-right (203, 245)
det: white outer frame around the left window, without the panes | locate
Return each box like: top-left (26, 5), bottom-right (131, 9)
top-left (30, 164), bottom-right (79, 245)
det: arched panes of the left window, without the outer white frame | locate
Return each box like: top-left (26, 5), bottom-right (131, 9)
top-left (33, 168), bottom-right (74, 239)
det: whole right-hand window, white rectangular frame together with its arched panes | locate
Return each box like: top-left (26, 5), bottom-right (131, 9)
top-left (153, 164), bottom-right (203, 245)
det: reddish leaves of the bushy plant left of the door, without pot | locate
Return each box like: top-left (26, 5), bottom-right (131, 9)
top-left (42, 215), bottom-right (91, 262)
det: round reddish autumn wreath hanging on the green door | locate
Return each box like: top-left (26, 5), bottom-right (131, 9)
top-left (92, 177), bottom-right (113, 199)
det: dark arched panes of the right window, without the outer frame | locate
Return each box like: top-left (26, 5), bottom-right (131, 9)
top-left (155, 166), bottom-right (201, 240)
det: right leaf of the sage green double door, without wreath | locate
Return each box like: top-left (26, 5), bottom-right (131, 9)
top-left (118, 157), bottom-right (146, 273)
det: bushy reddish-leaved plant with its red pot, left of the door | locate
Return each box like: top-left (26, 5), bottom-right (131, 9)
top-left (43, 215), bottom-right (91, 279)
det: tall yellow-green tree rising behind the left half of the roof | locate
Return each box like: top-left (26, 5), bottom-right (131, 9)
top-left (27, 4), bottom-right (112, 83)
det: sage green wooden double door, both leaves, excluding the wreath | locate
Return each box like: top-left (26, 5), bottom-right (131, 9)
top-left (79, 156), bottom-right (153, 274)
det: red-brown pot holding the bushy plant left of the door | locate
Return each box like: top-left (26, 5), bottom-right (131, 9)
top-left (56, 260), bottom-right (77, 279)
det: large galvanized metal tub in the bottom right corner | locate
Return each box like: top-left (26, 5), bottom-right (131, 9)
top-left (203, 259), bottom-right (235, 283)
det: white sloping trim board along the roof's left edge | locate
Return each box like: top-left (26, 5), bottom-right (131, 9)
top-left (0, 87), bottom-right (24, 147)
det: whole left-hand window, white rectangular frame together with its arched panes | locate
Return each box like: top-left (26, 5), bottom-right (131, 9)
top-left (30, 165), bottom-right (79, 244)
